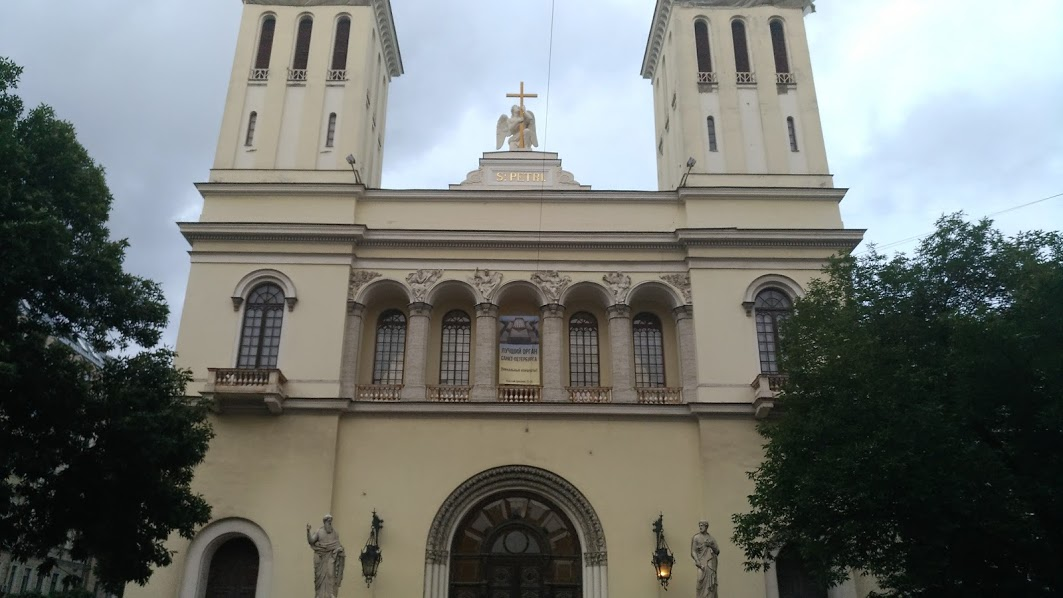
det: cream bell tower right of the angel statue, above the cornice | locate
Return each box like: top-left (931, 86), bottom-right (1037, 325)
top-left (642, 0), bottom-right (832, 190)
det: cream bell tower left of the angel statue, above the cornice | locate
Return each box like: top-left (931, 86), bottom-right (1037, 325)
top-left (212, 0), bottom-right (403, 187)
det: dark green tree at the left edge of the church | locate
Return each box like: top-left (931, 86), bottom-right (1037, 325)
top-left (0, 58), bottom-right (212, 591)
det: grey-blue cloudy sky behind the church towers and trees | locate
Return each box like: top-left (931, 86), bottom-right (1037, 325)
top-left (0, 0), bottom-right (1063, 344)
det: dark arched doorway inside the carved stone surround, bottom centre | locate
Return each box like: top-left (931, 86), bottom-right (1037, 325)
top-left (449, 493), bottom-right (583, 598)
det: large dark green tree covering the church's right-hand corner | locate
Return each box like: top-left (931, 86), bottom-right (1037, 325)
top-left (733, 215), bottom-right (1063, 597)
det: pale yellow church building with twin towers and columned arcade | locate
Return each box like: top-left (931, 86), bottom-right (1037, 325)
top-left (125, 0), bottom-right (866, 598)
